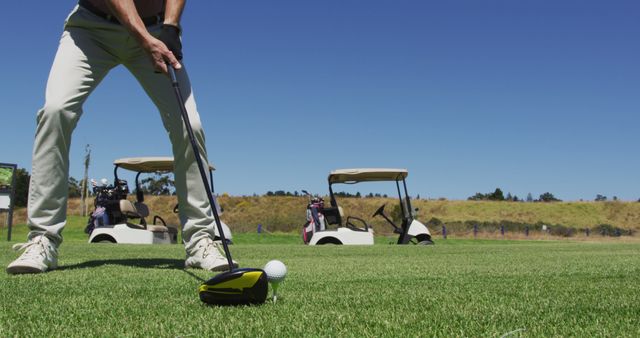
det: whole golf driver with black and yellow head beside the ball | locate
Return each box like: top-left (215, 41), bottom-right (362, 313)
top-left (167, 64), bottom-right (269, 305)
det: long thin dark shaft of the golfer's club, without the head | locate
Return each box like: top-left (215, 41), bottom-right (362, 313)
top-left (167, 64), bottom-right (233, 271)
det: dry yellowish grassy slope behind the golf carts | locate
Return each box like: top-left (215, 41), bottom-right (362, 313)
top-left (6, 196), bottom-right (640, 234)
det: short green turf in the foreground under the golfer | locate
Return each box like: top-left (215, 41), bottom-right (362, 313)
top-left (0, 230), bottom-right (640, 337)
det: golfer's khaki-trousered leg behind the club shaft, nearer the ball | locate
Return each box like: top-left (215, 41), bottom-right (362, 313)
top-left (125, 57), bottom-right (216, 249)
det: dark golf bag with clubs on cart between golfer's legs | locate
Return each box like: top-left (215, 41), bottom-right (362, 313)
top-left (84, 179), bottom-right (129, 235)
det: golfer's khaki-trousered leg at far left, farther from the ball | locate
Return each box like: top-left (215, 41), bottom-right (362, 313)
top-left (27, 14), bottom-right (115, 245)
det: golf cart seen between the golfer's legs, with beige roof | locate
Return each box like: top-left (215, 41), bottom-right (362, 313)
top-left (85, 157), bottom-right (231, 244)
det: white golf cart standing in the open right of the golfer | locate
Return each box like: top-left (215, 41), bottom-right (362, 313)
top-left (308, 168), bottom-right (433, 245)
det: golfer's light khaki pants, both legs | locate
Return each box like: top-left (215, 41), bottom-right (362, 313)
top-left (28, 6), bottom-right (215, 250)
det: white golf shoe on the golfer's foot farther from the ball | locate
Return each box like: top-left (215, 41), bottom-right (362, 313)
top-left (7, 236), bottom-right (58, 275)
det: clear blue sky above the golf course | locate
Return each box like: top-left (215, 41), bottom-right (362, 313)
top-left (0, 0), bottom-right (640, 200)
